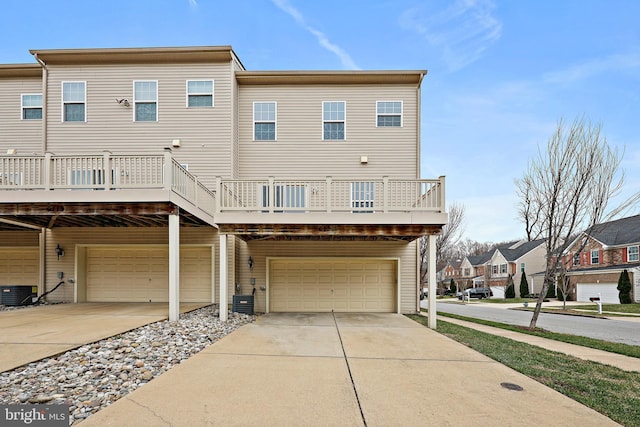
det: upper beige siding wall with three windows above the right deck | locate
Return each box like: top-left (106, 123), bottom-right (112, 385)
top-left (239, 85), bottom-right (418, 179)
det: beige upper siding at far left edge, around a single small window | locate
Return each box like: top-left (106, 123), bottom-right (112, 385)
top-left (0, 78), bottom-right (42, 155)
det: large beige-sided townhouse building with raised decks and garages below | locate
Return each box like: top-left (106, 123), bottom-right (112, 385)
top-left (0, 46), bottom-right (447, 320)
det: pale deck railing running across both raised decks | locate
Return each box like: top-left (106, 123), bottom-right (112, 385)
top-left (0, 152), bottom-right (445, 215)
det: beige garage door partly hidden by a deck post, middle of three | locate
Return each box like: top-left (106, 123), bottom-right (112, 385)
top-left (87, 247), bottom-right (211, 302)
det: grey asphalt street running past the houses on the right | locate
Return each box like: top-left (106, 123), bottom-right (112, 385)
top-left (430, 301), bottom-right (640, 345)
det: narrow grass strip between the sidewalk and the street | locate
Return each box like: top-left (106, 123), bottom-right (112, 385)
top-left (438, 312), bottom-right (640, 358)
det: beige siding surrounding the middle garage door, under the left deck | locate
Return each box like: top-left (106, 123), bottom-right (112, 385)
top-left (45, 227), bottom-right (222, 302)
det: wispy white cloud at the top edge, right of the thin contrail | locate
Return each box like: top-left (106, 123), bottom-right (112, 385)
top-left (400, 0), bottom-right (502, 71)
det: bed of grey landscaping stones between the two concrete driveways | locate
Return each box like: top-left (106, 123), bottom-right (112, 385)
top-left (0, 306), bottom-right (257, 424)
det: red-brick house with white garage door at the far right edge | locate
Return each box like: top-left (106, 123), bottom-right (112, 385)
top-left (563, 215), bottom-right (640, 304)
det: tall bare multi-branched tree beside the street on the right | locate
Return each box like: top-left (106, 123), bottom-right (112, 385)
top-left (516, 117), bottom-right (640, 329)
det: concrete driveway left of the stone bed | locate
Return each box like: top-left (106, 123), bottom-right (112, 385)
top-left (0, 303), bottom-right (207, 372)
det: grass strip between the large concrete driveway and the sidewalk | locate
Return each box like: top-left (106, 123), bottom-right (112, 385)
top-left (409, 315), bottom-right (640, 426)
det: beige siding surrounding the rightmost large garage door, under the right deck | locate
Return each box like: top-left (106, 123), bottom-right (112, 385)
top-left (237, 240), bottom-right (417, 313)
